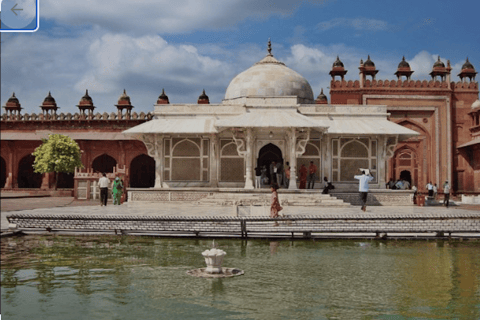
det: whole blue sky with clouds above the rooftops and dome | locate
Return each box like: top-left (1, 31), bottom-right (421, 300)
top-left (1, 0), bottom-right (480, 113)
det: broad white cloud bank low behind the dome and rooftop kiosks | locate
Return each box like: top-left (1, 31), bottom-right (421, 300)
top-left (1, 29), bottom-right (470, 113)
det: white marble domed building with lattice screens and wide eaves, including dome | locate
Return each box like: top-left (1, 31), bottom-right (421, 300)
top-left (124, 50), bottom-right (417, 189)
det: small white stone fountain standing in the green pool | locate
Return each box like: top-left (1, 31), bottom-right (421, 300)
top-left (187, 240), bottom-right (244, 278)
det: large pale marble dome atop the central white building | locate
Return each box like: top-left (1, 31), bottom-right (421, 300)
top-left (225, 55), bottom-right (314, 103)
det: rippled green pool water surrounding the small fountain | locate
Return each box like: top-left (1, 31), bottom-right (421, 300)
top-left (1, 236), bottom-right (480, 319)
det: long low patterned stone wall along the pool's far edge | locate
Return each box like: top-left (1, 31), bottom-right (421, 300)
top-left (7, 213), bottom-right (480, 237)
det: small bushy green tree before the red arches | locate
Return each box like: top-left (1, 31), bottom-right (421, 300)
top-left (32, 134), bottom-right (83, 190)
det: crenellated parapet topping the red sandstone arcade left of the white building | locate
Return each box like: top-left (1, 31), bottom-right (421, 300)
top-left (0, 112), bottom-right (153, 122)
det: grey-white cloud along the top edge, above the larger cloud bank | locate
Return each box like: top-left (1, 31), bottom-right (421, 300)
top-left (42, 0), bottom-right (310, 34)
